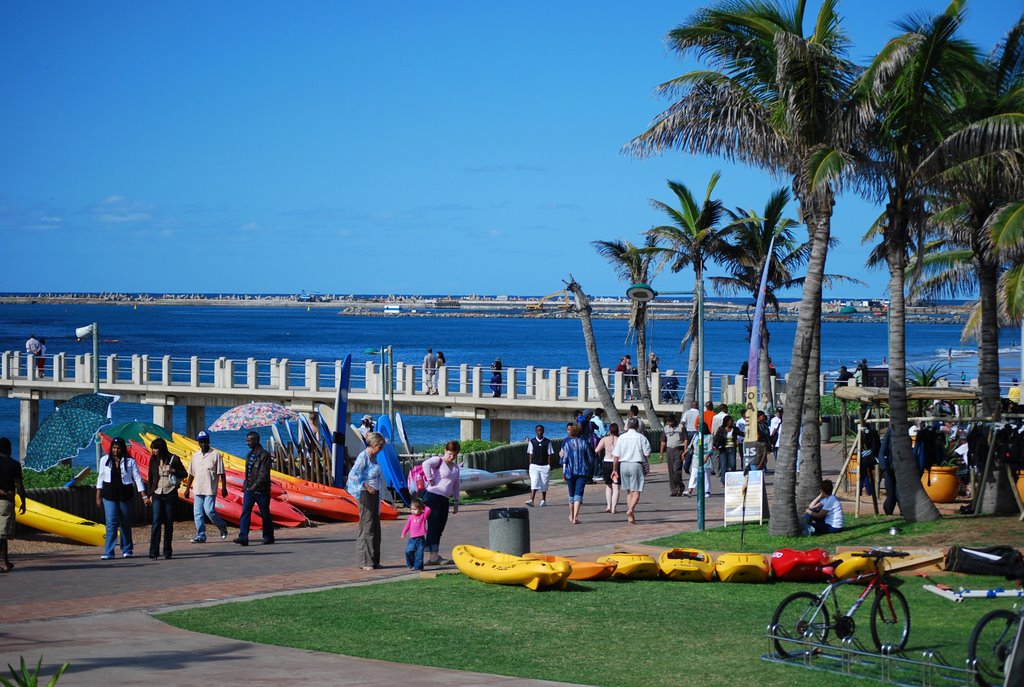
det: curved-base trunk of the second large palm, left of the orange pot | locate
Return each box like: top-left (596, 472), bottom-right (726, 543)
top-left (887, 254), bottom-right (941, 522)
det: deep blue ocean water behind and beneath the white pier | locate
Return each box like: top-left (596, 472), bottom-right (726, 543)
top-left (0, 304), bottom-right (1020, 463)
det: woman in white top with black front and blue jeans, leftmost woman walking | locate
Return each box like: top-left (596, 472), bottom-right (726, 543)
top-left (96, 436), bottom-right (150, 561)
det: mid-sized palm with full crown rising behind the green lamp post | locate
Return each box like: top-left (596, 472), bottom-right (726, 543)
top-left (647, 172), bottom-right (728, 407)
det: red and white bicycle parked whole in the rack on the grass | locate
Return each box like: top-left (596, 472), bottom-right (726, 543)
top-left (771, 548), bottom-right (910, 658)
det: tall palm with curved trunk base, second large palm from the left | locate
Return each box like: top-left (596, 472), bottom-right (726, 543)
top-left (860, 0), bottom-right (1021, 521)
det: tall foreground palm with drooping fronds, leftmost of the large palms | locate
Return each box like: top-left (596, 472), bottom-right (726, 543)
top-left (628, 0), bottom-right (857, 534)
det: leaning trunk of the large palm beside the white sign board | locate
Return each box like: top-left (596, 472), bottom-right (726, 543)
top-left (768, 188), bottom-right (833, 536)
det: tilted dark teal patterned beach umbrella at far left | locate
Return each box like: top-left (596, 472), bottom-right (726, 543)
top-left (25, 393), bottom-right (118, 471)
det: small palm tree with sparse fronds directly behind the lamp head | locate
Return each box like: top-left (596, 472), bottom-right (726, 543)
top-left (592, 235), bottom-right (662, 430)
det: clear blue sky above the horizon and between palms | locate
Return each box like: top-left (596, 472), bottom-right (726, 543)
top-left (0, 0), bottom-right (1024, 297)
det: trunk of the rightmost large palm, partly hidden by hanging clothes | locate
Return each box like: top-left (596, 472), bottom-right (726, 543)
top-left (975, 261), bottom-right (1017, 515)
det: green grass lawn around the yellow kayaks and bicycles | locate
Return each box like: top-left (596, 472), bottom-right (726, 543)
top-left (160, 518), bottom-right (1013, 687)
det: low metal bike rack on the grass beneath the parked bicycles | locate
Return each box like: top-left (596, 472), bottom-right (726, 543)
top-left (761, 625), bottom-right (976, 687)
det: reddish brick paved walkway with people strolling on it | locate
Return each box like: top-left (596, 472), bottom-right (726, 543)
top-left (0, 449), bottom-right (842, 687)
